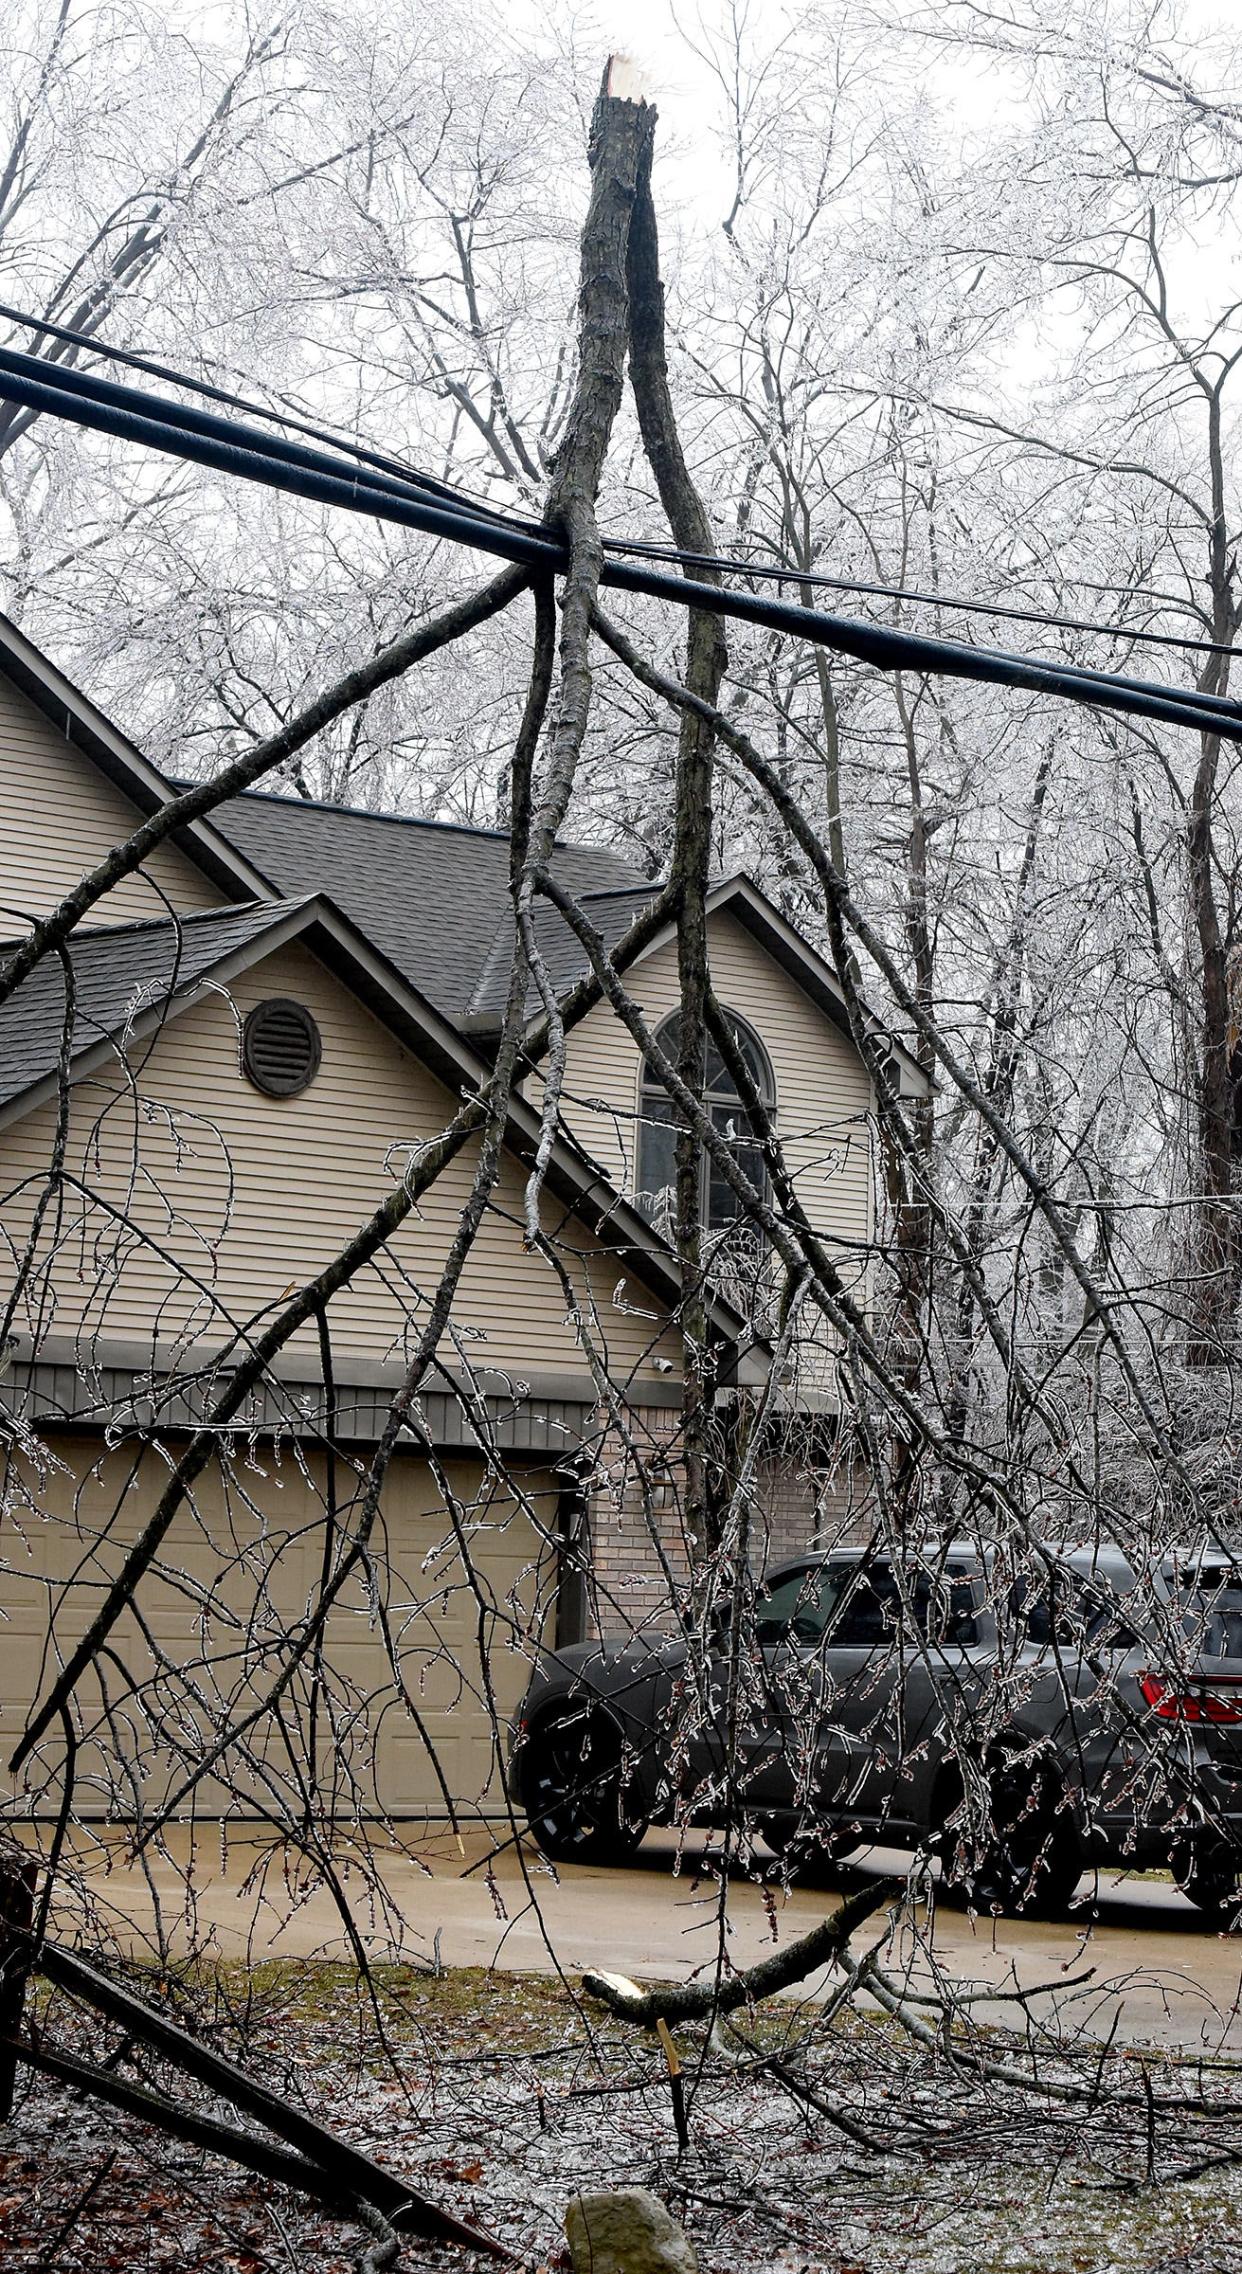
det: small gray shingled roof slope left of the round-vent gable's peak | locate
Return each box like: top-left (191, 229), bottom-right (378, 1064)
top-left (0, 901), bottom-right (289, 1105)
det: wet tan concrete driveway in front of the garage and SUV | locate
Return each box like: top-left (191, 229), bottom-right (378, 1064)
top-left (36, 1828), bottom-right (1242, 2053)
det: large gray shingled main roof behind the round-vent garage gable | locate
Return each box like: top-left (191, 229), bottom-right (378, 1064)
top-left (197, 791), bottom-right (651, 1019)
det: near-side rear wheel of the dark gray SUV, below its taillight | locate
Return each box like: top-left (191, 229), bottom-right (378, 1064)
top-left (946, 1753), bottom-right (1083, 1912)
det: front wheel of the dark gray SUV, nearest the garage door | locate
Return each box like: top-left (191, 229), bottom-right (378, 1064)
top-left (519, 1703), bottom-right (648, 1862)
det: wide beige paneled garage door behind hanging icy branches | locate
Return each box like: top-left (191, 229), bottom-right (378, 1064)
top-left (0, 1435), bottom-right (557, 1819)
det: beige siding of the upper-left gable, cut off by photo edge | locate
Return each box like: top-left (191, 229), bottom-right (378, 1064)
top-left (0, 675), bottom-right (223, 939)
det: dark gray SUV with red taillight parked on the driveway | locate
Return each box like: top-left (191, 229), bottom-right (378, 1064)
top-left (510, 1544), bottom-right (1242, 1917)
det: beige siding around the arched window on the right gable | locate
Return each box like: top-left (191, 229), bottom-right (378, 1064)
top-left (550, 912), bottom-right (871, 1291)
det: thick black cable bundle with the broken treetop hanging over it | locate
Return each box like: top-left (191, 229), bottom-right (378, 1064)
top-left (0, 348), bottom-right (1242, 741)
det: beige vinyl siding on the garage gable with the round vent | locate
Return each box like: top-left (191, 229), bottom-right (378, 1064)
top-left (0, 946), bottom-right (676, 1394)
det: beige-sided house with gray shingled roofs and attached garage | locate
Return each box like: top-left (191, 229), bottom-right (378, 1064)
top-left (0, 621), bottom-right (919, 1817)
